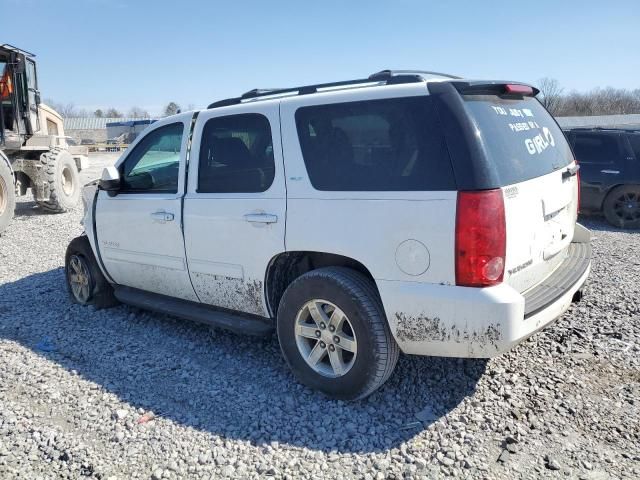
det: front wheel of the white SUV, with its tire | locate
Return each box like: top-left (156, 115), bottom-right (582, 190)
top-left (65, 235), bottom-right (119, 309)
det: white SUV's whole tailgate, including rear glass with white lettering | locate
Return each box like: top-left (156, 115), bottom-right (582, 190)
top-left (463, 95), bottom-right (578, 292)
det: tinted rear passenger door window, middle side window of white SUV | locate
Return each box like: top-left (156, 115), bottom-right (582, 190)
top-left (197, 113), bottom-right (275, 193)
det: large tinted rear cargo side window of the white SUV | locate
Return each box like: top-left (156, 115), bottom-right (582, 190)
top-left (296, 96), bottom-right (455, 191)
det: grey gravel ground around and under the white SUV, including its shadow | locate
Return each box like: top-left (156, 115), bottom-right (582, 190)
top-left (0, 155), bottom-right (640, 479)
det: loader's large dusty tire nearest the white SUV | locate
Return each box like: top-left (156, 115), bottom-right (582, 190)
top-left (36, 148), bottom-right (80, 213)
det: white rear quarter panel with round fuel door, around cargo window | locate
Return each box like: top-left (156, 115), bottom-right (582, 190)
top-left (280, 84), bottom-right (457, 284)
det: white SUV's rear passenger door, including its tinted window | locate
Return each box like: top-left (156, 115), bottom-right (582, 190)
top-left (184, 102), bottom-right (286, 316)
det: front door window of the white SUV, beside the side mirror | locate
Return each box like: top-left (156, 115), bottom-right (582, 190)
top-left (120, 123), bottom-right (184, 193)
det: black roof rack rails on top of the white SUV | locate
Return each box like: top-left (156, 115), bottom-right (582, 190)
top-left (207, 70), bottom-right (460, 108)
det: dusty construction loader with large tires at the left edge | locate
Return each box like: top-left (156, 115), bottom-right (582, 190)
top-left (0, 44), bottom-right (88, 233)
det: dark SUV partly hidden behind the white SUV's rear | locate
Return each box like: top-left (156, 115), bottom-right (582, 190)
top-left (565, 128), bottom-right (640, 228)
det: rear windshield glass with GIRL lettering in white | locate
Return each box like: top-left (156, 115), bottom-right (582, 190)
top-left (463, 95), bottom-right (573, 185)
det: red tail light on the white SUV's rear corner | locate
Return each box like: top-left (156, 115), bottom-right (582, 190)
top-left (455, 189), bottom-right (507, 287)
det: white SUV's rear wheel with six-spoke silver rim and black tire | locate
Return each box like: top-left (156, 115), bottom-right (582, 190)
top-left (277, 267), bottom-right (399, 400)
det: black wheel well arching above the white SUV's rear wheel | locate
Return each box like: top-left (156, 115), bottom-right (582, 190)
top-left (265, 251), bottom-right (377, 318)
